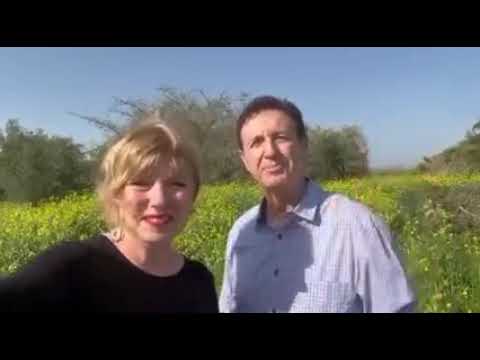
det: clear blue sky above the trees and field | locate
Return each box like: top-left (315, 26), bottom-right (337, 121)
top-left (0, 48), bottom-right (480, 167)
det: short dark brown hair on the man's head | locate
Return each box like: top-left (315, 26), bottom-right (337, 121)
top-left (236, 95), bottom-right (307, 149)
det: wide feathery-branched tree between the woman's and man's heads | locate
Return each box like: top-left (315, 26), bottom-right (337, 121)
top-left (74, 87), bottom-right (248, 182)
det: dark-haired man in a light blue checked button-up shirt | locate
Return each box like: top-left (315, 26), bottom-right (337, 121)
top-left (220, 96), bottom-right (415, 313)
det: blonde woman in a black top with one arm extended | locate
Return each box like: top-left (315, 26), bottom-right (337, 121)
top-left (0, 114), bottom-right (218, 313)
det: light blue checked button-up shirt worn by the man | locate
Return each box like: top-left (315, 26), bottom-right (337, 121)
top-left (219, 180), bottom-right (415, 313)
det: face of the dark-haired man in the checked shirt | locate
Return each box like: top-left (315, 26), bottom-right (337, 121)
top-left (240, 110), bottom-right (307, 190)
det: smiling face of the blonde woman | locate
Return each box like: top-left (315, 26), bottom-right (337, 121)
top-left (115, 159), bottom-right (195, 248)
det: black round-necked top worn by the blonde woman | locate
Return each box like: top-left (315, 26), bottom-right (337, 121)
top-left (0, 235), bottom-right (218, 313)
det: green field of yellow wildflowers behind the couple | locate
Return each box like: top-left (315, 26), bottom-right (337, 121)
top-left (0, 173), bottom-right (480, 312)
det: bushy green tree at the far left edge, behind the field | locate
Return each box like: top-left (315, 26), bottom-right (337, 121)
top-left (0, 119), bottom-right (91, 202)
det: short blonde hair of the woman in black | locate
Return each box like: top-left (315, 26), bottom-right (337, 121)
top-left (96, 112), bottom-right (200, 228)
